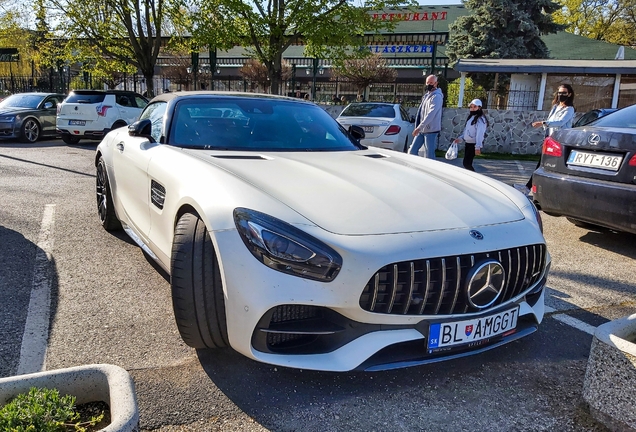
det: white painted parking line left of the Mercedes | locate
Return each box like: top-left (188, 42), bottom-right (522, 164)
top-left (17, 204), bottom-right (55, 375)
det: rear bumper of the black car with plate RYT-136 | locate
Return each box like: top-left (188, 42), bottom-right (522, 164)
top-left (532, 167), bottom-right (636, 234)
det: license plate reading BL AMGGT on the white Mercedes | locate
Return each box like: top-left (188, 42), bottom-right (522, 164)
top-left (428, 306), bottom-right (519, 352)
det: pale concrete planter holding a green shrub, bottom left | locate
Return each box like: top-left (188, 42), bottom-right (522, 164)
top-left (0, 364), bottom-right (139, 432)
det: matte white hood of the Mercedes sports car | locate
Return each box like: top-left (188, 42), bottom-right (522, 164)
top-left (191, 150), bottom-right (524, 235)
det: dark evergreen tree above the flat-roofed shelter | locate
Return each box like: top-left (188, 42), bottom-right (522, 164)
top-left (446, 0), bottom-right (564, 63)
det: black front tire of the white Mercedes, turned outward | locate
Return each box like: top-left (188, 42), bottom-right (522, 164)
top-left (170, 213), bottom-right (229, 348)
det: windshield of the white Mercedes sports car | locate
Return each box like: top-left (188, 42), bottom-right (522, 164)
top-left (168, 96), bottom-right (361, 151)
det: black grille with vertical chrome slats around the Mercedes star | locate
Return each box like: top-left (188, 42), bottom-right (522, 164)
top-left (360, 244), bottom-right (546, 315)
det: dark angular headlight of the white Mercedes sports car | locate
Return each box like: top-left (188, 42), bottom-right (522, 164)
top-left (234, 208), bottom-right (342, 282)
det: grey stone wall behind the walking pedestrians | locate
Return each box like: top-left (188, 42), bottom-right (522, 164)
top-left (323, 105), bottom-right (549, 154)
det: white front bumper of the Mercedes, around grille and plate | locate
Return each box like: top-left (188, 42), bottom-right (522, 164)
top-left (214, 221), bottom-right (550, 371)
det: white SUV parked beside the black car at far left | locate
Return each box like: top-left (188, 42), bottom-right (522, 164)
top-left (56, 90), bottom-right (148, 144)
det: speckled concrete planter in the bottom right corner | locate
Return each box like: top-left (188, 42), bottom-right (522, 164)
top-left (583, 314), bottom-right (636, 432)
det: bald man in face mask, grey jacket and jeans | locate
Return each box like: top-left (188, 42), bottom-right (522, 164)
top-left (409, 75), bottom-right (444, 159)
